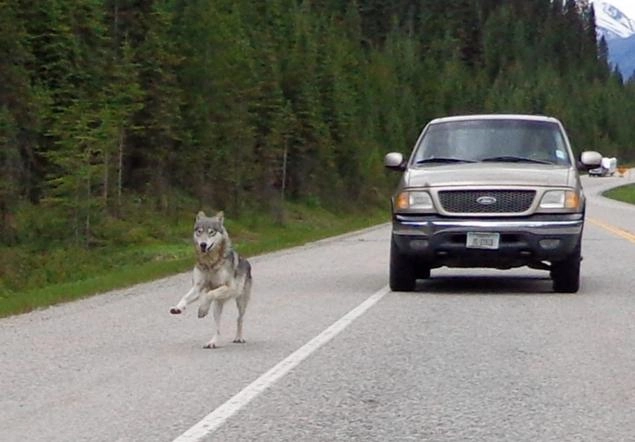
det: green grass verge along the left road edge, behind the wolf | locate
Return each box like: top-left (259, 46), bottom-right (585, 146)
top-left (0, 205), bottom-right (389, 317)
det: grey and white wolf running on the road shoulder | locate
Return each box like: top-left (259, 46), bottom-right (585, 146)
top-left (170, 212), bottom-right (252, 348)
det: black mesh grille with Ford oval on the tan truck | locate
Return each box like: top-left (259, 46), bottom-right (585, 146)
top-left (439, 190), bottom-right (536, 213)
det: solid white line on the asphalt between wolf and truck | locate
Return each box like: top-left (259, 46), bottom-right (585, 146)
top-left (174, 287), bottom-right (390, 442)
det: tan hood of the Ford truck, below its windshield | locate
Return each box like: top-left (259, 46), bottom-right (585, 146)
top-left (403, 163), bottom-right (577, 187)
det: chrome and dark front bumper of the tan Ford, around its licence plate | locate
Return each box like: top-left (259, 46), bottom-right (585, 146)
top-left (392, 213), bottom-right (584, 268)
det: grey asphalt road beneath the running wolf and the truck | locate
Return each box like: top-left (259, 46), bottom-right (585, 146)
top-left (0, 171), bottom-right (635, 442)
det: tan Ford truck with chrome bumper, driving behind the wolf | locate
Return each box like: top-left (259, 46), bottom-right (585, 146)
top-left (384, 115), bottom-right (602, 293)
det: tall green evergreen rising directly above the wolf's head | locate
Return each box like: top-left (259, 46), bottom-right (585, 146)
top-left (178, 0), bottom-right (257, 210)
